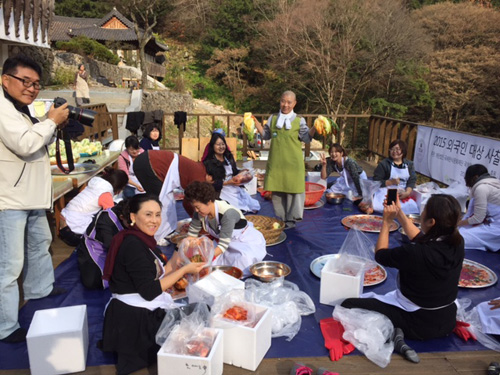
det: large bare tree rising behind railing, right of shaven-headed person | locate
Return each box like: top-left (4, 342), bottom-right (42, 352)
top-left (254, 0), bottom-right (422, 142)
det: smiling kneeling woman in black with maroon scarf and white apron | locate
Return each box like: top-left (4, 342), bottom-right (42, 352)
top-left (100, 194), bottom-right (204, 374)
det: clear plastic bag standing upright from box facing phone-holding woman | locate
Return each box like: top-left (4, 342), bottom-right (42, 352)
top-left (336, 226), bottom-right (377, 271)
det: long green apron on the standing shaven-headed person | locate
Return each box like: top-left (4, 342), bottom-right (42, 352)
top-left (264, 115), bottom-right (306, 194)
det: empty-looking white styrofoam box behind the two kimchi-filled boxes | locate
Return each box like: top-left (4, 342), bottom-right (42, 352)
top-left (187, 270), bottom-right (245, 306)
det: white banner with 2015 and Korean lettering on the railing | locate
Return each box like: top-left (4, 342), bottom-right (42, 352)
top-left (413, 125), bottom-right (500, 185)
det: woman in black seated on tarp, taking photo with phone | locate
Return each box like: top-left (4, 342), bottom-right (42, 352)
top-left (342, 194), bottom-right (464, 362)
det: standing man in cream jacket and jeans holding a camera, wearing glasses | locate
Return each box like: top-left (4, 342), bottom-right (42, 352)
top-left (0, 55), bottom-right (69, 343)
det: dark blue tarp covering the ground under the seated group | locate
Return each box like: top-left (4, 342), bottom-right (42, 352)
top-left (0, 197), bottom-right (500, 369)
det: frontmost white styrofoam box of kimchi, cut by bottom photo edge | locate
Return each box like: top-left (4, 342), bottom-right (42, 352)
top-left (158, 328), bottom-right (224, 375)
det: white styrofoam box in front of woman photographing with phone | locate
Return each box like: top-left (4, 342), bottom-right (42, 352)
top-left (319, 257), bottom-right (365, 306)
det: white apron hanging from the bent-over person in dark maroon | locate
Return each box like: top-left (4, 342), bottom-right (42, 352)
top-left (155, 153), bottom-right (181, 241)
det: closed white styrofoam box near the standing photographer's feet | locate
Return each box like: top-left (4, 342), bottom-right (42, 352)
top-left (26, 305), bottom-right (89, 375)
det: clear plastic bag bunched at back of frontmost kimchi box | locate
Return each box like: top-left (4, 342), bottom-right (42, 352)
top-left (156, 303), bottom-right (210, 346)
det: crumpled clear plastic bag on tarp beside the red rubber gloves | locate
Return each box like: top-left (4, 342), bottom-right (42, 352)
top-left (333, 305), bottom-right (394, 368)
